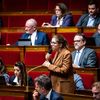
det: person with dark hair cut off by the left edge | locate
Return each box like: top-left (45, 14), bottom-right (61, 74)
top-left (0, 58), bottom-right (9, 84)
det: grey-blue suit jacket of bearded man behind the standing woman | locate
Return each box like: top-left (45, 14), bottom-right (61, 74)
top-left (72, 47), bottom-right (96, 68)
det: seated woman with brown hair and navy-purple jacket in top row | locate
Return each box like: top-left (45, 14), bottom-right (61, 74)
top-left (42, 3), bottom-right (74, 27)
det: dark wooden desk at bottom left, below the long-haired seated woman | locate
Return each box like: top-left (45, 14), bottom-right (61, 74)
top-left (0, 86), bottom-right (33, 100)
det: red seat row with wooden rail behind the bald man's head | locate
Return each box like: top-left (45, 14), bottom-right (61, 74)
top-left (0, 11), bottom-right (83, 27)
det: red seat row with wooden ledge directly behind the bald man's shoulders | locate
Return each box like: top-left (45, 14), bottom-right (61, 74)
top-left (0, 27), bottom-right (96, 45)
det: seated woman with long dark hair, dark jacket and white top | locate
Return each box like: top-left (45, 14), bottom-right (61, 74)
top-left (9, 61), bottom-right (33, 86)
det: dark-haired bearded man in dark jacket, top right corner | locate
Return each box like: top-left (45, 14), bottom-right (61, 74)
top-left (76, 2), bottom-right (100, 27)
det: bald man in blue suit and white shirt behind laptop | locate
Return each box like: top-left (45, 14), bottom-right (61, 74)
top-left (16, 18), bottom-right (49, 46)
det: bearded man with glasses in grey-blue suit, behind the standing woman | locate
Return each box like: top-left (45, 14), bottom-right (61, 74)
top-left (72, 33), bottom-right (97, 68)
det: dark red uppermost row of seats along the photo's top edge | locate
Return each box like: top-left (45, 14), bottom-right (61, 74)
top-left (0, 0), bottom-right (91, 11)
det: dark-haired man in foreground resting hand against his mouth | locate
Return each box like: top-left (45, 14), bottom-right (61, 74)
top-left (33, 74), bottom-right (63, 100)
